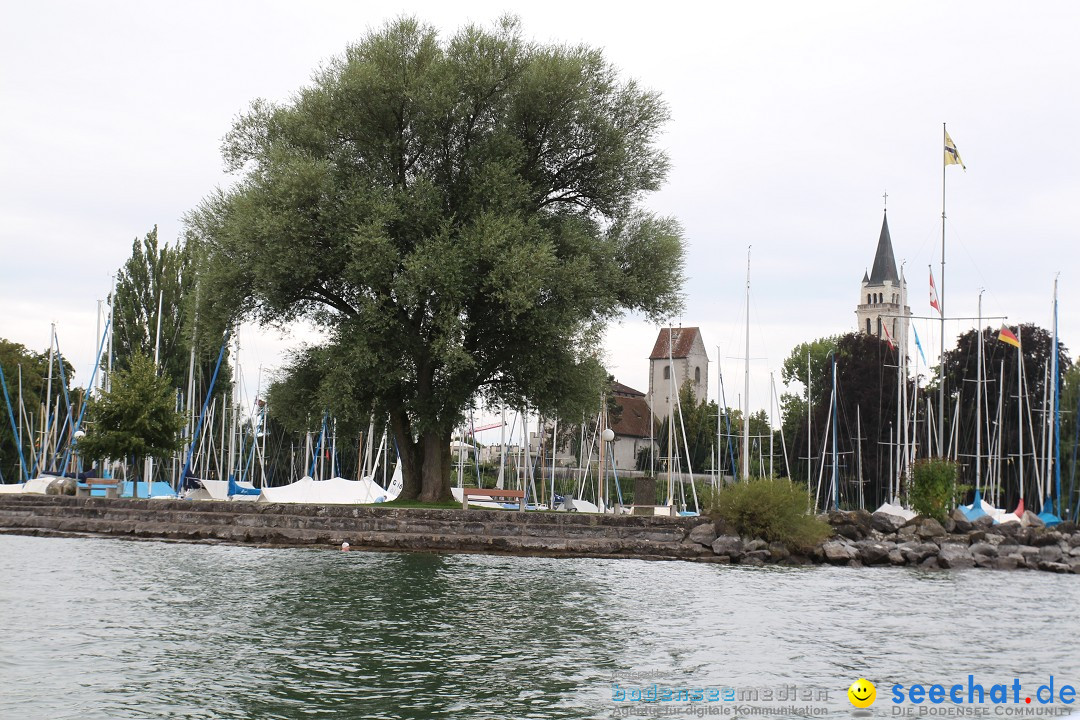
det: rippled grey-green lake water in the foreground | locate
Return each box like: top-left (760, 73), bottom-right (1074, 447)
top-left (0, 535), bottom-right (1080, 720)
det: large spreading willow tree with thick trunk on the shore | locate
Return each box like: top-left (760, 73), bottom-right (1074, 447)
top-left (189, 18), bottom-right (683, 501)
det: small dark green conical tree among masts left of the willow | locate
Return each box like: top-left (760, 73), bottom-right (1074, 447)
top-left (76, 353), bottom-right (184, 468)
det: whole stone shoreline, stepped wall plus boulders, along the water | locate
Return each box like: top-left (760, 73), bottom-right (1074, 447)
top-left (0, 494), bottom-right (1080, 573)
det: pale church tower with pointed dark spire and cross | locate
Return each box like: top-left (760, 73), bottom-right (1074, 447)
top-left (855, 209), bottom-right (912, 351)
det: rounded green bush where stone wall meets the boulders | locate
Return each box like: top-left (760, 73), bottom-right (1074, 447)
top-left (703, 478), bottom-right (832, 549)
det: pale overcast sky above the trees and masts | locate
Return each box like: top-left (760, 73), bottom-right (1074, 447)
top-left (0, 0), bottom-right (1080, 433)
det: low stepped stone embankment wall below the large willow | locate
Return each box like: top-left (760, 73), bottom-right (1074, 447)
top-left (0, 495), bottom-right (713, 559)
